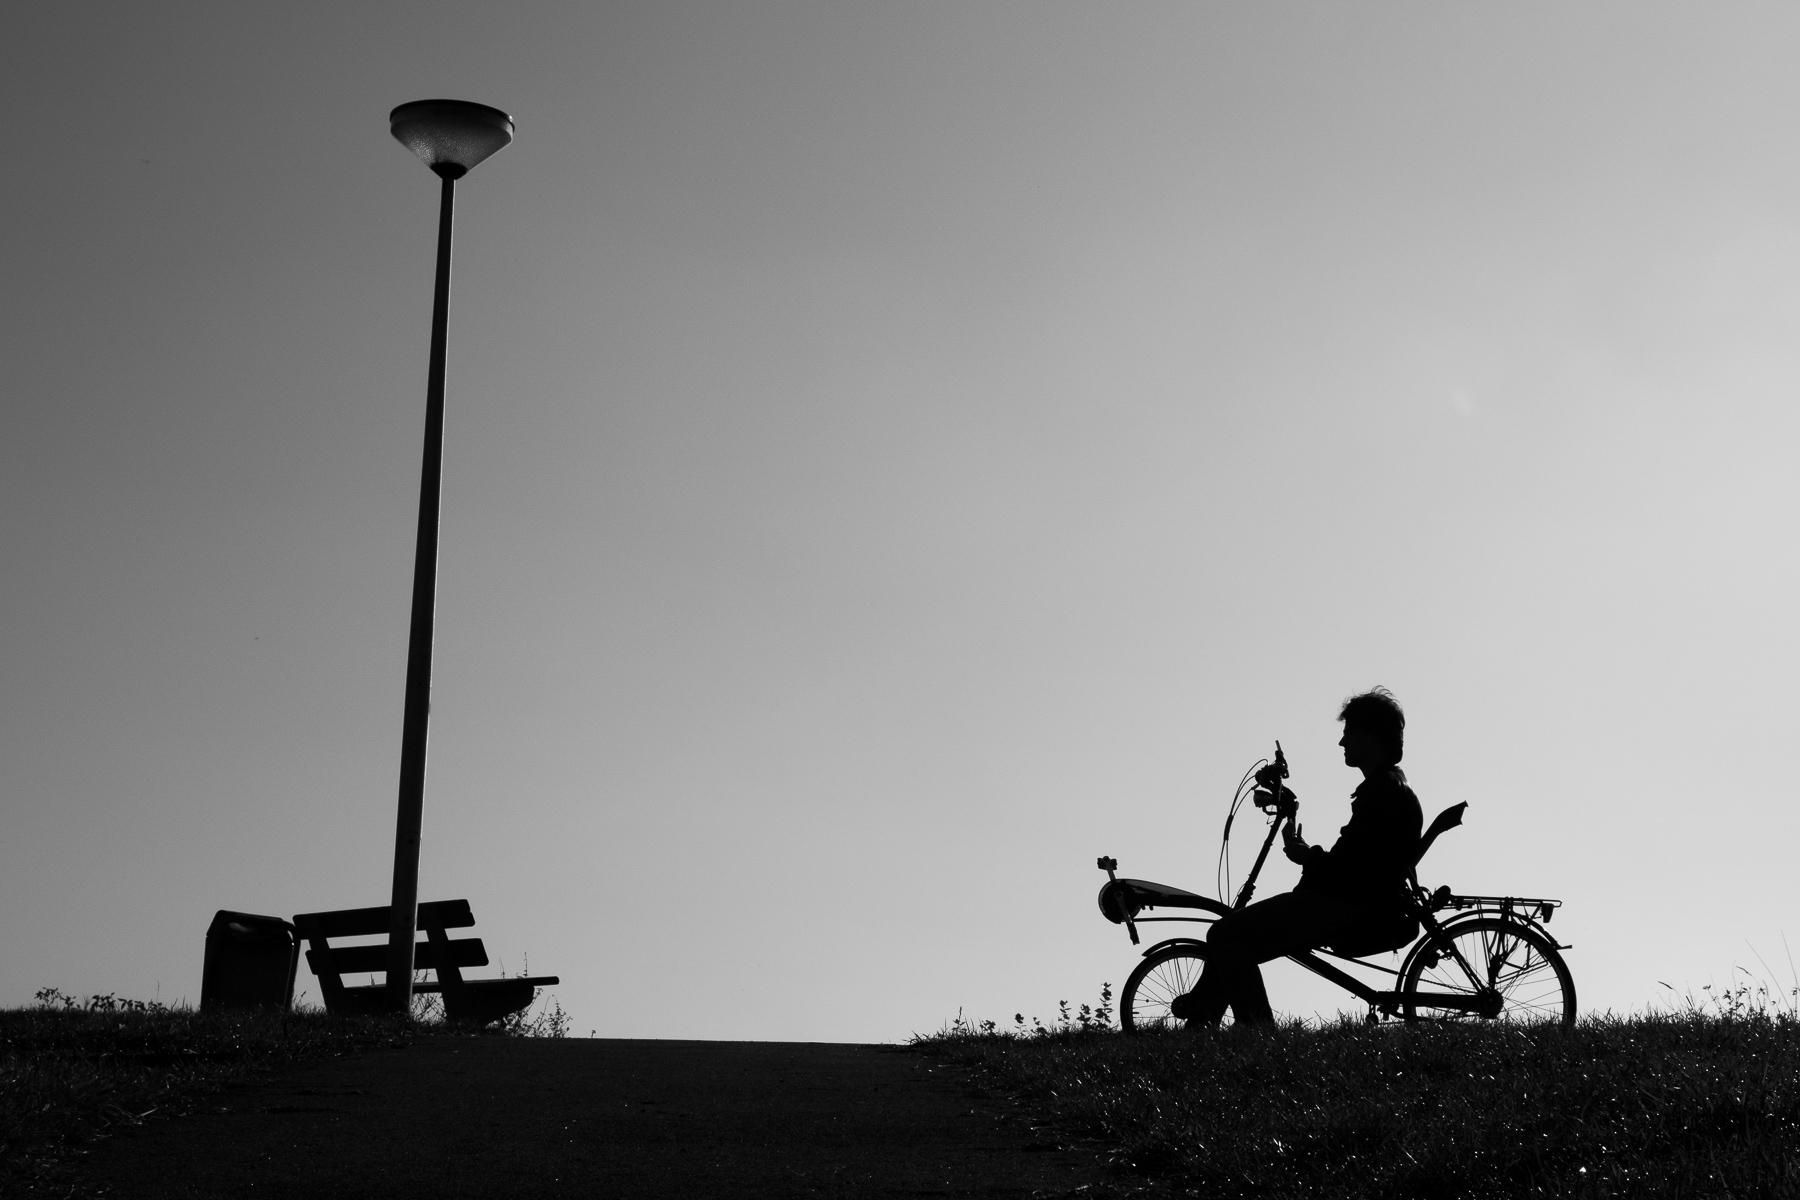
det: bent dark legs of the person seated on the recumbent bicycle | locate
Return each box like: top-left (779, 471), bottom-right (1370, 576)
top-left (1170, 892), bottom-right (1354, 1025)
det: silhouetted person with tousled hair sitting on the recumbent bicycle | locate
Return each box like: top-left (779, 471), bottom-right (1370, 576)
top-left (1168, 687), bottom-right (1424, 1025)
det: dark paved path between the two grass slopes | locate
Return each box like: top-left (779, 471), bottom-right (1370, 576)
top-left (83, 1038), bottom-right (1105, 1200)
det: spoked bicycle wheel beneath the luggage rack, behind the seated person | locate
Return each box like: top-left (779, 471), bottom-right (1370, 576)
top-left (1400, 918), bottom-right (1575, 1029)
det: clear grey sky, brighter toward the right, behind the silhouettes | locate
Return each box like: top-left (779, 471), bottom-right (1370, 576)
top-left (0, 0), bottom-right (1800, 1042)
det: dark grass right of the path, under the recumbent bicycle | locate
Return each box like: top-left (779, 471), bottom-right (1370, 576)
top-left (916, 991), bottom-right (1800, 1198)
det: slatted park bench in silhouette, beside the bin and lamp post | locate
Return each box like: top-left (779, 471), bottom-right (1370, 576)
top-left (293, 900), bottom-right (562, 1025)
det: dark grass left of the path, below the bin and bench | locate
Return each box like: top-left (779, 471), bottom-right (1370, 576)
top-left (0, 988), bottom-right (569, 1195)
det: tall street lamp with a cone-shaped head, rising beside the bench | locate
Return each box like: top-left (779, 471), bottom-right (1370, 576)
top-left (387, 101), bottom-right (513, 1013)
